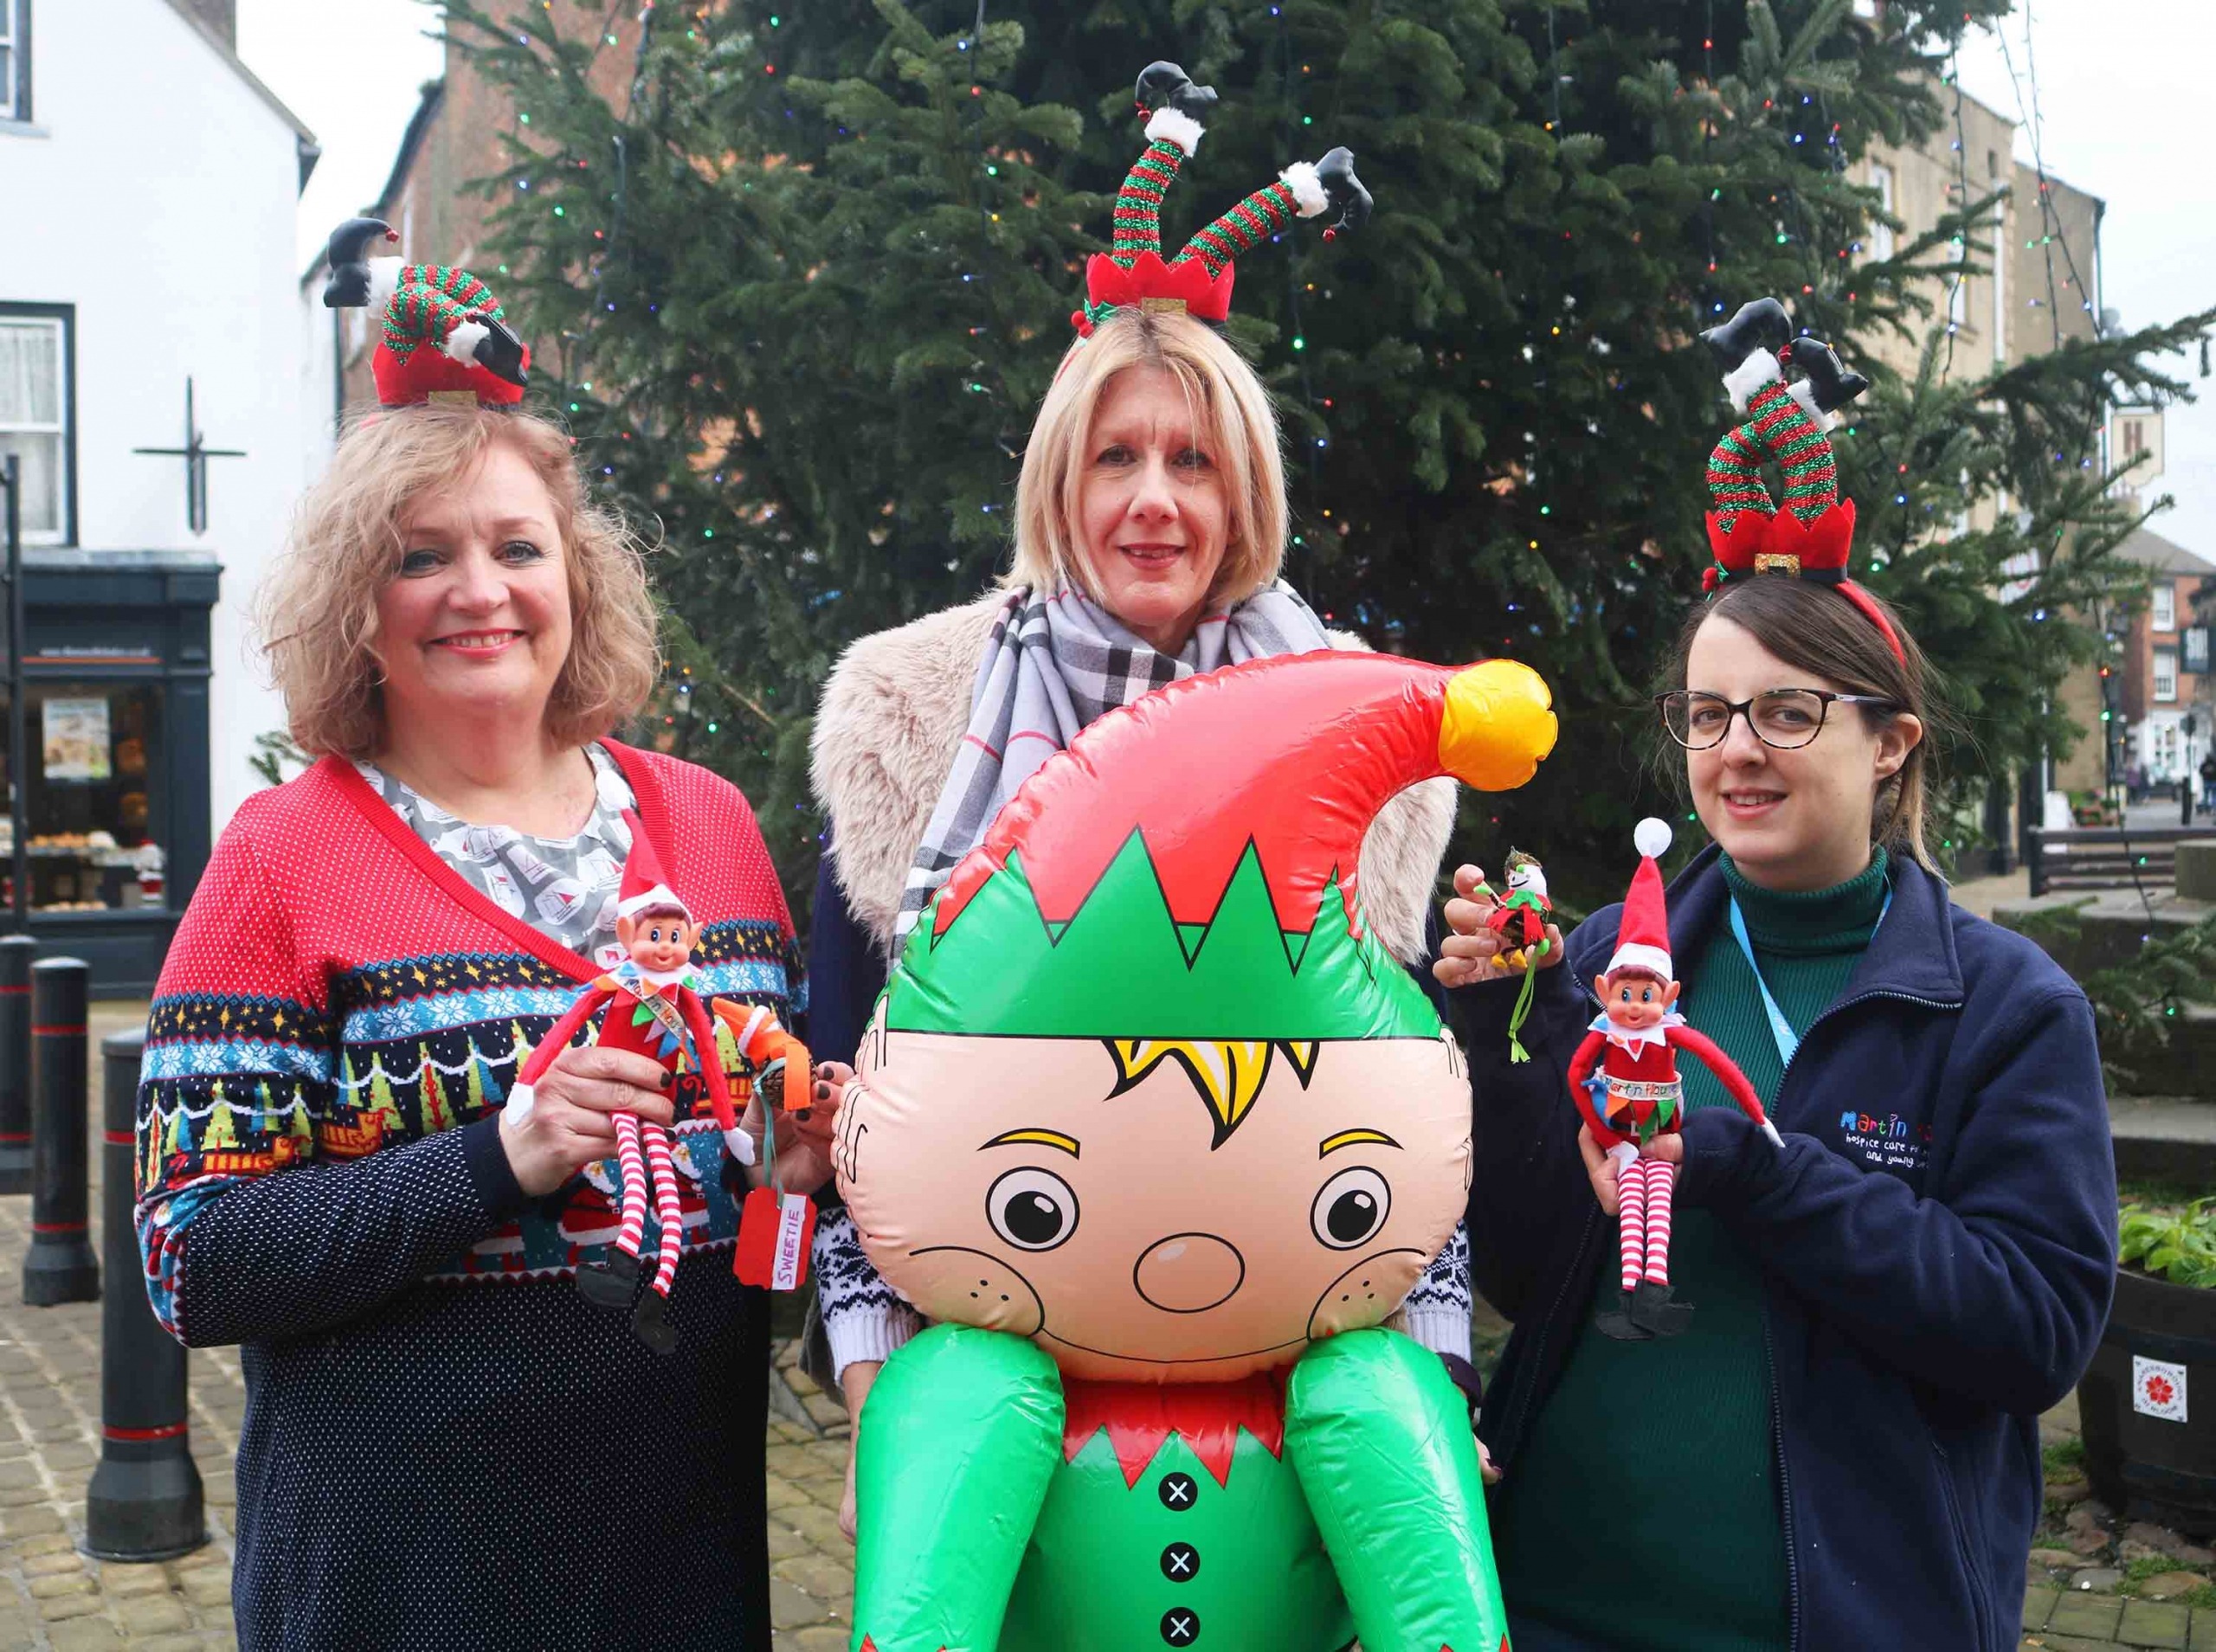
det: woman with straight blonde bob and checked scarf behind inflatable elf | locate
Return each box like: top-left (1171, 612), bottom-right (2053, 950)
top-left (808, 305), bottom-right (1469, 1530)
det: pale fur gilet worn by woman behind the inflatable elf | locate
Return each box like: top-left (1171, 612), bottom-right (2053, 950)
top-left (811, 591), bottom-right (1453, 963)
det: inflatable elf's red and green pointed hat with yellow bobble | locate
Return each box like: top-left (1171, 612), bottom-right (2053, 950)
top-left (884, 651), bottom-right (1556, 1040)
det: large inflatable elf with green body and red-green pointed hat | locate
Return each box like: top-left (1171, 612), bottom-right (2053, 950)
top-left (834, 653), bottom-right (1556, 1652)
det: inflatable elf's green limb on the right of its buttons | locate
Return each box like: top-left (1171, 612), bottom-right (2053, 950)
top-left (1285, 1331), bottom-right (1509, 1652)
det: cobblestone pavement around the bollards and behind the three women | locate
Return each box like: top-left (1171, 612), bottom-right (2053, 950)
top-left (0, 1006), bottom-right (2181, 1652)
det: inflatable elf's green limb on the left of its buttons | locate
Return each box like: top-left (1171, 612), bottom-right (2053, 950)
top-left (848, 1324), bottom-right (1064, 1652)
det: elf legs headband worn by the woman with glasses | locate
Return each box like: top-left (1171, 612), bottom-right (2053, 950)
top-left (1700, 299), bottom-right (1908, 665)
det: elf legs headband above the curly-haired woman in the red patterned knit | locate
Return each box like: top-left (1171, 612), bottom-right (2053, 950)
top-left (324, 217), bottom-right (531, 408)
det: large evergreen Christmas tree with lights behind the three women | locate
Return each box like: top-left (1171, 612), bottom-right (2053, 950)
top-left (448, 0), bottom-right (2212, 906)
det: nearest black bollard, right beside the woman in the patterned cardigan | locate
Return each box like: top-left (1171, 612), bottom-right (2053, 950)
top-left (84, 1027), bottom-right (209, 1561)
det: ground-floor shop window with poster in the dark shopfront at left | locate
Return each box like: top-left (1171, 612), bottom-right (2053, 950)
top-left (0, 682), bottom-right (169, 912)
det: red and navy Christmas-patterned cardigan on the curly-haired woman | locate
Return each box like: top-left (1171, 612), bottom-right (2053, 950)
top-left (138, 744), bottom-right (798, 1652)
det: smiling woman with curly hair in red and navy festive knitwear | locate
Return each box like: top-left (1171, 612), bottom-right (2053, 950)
top-left (139, 403), bottom-right (798, 1652)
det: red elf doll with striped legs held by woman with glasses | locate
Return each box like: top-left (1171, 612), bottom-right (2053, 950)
top-left (1569, 820), bottom-right (1781, 1342)
